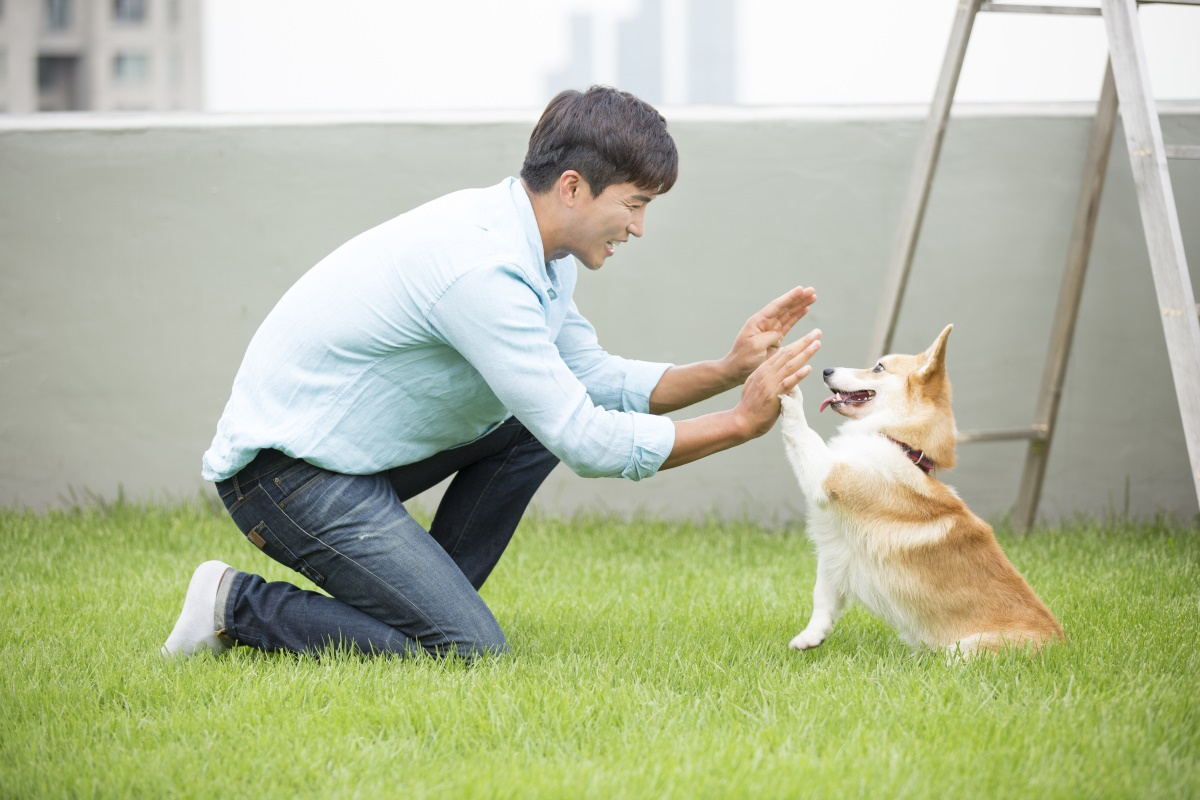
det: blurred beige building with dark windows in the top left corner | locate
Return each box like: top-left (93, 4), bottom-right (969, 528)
top-left (0, 0), bottom-right (203, 114)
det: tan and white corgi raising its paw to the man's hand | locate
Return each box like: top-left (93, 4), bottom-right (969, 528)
top-left (780, 325), bottom-right (1063, 656)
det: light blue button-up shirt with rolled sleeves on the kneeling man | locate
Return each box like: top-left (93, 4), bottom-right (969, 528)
top-left (203, 178), bottom-right (674, 481)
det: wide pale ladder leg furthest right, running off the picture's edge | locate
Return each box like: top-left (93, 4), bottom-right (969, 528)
top-left (1100, 0), bottom-right (1200, 510)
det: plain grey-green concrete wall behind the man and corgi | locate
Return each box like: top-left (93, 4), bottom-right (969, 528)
top-left (0, 106), bottom-right (1200, 524)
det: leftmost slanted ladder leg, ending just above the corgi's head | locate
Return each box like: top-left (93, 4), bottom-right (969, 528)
top-left (868, 0), bottom-right (982, 361)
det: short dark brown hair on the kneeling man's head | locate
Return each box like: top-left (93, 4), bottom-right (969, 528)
top-left (521, 86), bottom-right (679, 197)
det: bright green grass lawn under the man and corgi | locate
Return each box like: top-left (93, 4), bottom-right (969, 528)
top-left (0, 503), bottom-right (1200, 800)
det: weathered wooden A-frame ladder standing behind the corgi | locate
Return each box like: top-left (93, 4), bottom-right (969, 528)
top-left (868, 0), bottom-right (1200, 530)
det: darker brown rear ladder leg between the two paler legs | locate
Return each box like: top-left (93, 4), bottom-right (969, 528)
top-left (1013, 61), bottom-right (1117, 531)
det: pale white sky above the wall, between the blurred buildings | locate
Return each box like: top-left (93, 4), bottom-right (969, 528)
top-left (204, 0), bottom-right (1200, 112)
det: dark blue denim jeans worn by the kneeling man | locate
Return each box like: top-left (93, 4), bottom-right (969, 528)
top-left (217, 419), bottom-right (558, 658)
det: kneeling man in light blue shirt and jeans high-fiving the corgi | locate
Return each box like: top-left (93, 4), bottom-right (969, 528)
top-left (162, 86), bottom-right (820, 658)
